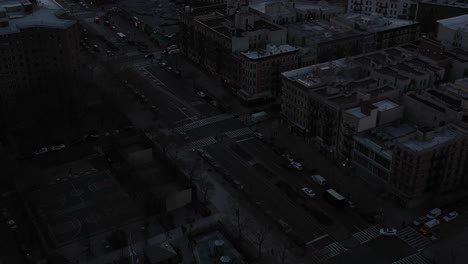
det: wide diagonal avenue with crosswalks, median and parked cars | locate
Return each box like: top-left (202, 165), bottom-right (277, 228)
top-left (56, 1), bottom-right (440, 263)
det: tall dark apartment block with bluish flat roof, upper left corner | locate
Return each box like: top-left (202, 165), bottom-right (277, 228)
top-left (0, 0), bottom-right (82, 134)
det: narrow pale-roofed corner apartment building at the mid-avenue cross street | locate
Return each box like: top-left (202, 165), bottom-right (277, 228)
top-left (237, 44), bottom-right (299, 102)
